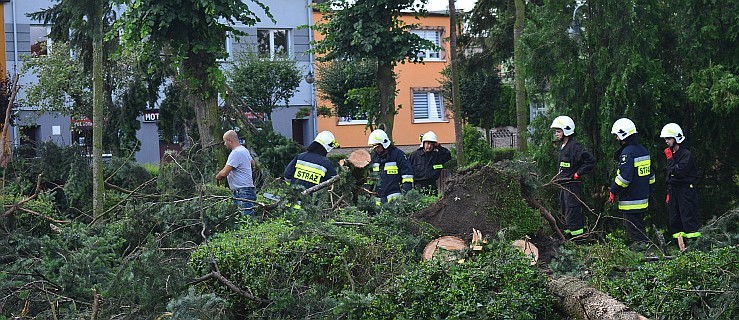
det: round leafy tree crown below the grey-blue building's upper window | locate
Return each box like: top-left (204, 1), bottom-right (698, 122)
top-left (226, 52), bottom-right (303, 119)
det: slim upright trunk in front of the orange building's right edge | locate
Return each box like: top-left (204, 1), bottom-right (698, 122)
top-left (449, 0), bottom-right (467, 167)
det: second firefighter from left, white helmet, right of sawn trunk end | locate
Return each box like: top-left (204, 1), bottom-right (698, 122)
top-left (367, 129), bottom-right (413, 204)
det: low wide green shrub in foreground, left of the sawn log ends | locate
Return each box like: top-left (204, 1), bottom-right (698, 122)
top-left (191, 214), bottom-right (420, 318)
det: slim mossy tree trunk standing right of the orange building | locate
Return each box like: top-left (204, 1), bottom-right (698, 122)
top-left (513, 0), bottom-right (529, 153)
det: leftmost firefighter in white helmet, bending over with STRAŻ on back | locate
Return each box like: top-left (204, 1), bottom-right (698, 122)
top-left (284, 131), bottom-right (339, 188)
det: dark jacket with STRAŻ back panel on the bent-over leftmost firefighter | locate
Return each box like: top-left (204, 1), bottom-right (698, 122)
top-left (284, 147), bottom-right (336, 188)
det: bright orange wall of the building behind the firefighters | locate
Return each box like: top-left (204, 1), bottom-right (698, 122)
top-left (313, 12), bottom-right (455, 147)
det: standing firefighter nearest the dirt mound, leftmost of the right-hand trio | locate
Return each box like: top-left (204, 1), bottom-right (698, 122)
top-left (550, 116), bottom-right (595, 238)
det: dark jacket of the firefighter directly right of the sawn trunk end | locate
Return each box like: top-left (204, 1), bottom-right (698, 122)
top-left (369, 145), bottom-right (413, 202)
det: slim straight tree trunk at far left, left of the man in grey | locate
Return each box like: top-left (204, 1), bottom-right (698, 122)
top-left (90, 1), bottom-right (105, 220)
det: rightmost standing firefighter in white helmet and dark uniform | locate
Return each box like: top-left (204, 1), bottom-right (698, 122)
top-left (659, 123), bottom-right (701, 239)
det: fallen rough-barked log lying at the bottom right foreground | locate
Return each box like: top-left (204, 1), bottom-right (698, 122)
top-left (549, 276), bottom-right (647, 320)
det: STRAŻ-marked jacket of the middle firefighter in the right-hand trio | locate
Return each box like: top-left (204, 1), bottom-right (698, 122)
top-left (610, 139), bottom-right (655, 212)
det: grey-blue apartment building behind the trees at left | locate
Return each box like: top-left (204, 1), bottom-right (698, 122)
top-left (0, 0), bottom-right (316, 163)
